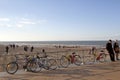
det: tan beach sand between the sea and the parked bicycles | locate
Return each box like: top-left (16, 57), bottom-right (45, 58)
top-left (0, 45), bottom-right (91, 71)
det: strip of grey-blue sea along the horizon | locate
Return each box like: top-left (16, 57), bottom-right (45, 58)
top-left (0, 41), bottom-right (113, 47)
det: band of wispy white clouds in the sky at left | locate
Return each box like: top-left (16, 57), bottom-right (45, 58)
top-left (0, 18), bottom-right (47, 28)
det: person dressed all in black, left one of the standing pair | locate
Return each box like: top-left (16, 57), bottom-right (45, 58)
top-left (106, 40), bottom-right (115, 61)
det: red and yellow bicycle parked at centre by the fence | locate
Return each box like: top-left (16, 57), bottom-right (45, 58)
top-left (60, 52), bottom-right (82, 68)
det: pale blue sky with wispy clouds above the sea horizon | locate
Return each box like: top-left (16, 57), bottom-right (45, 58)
top-left (0, 0), bottom-right (120, 41)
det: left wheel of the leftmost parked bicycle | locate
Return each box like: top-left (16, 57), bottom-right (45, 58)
top-left (6, 62), bottom-right (18, 74)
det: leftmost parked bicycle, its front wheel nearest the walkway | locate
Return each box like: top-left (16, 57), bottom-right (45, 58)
top-left (6, 55), bottom-right (32, 74)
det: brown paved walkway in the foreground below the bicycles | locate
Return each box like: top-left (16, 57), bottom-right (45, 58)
top-left (0, 61), bottom-right (120, 80)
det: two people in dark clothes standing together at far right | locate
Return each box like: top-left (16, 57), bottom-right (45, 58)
top-left (106, 40), bottom-right (119, 62)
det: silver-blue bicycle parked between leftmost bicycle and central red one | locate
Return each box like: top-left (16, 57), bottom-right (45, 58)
top-left (27, 56), bottom-right (57, 72)
